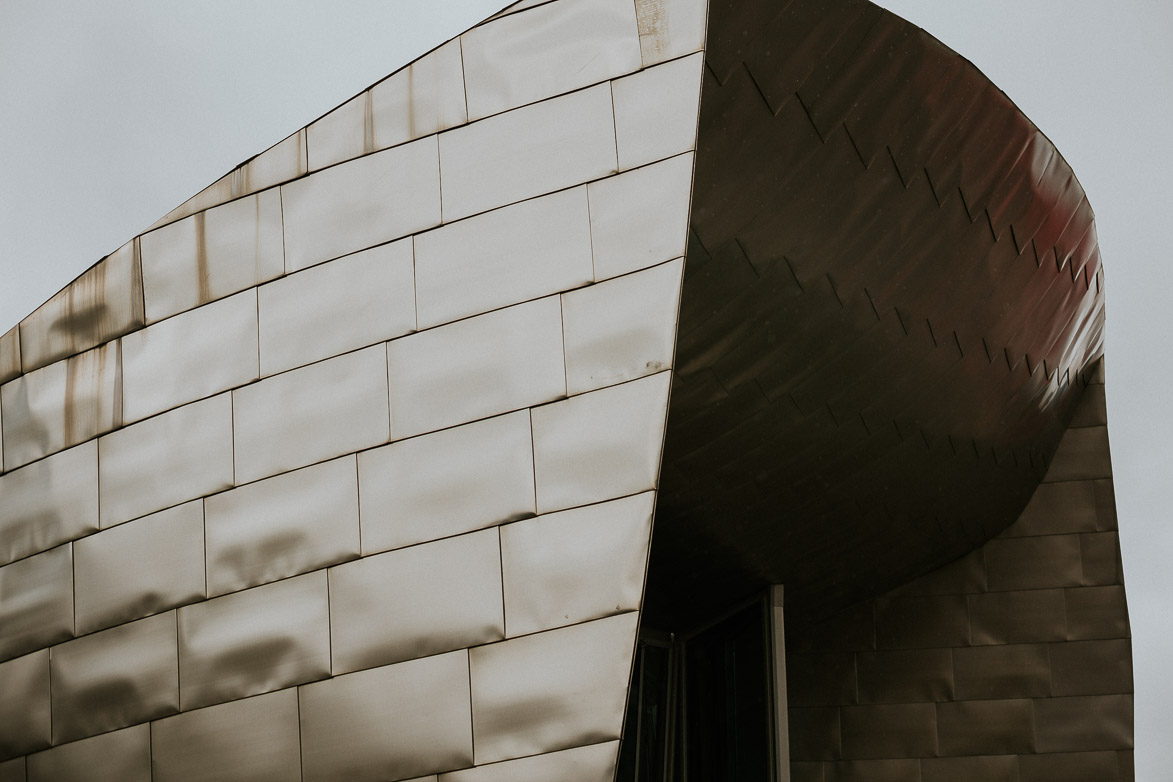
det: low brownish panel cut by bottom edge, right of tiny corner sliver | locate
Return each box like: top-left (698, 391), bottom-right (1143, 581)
top-left (28, 725), bottom-right (151, 782)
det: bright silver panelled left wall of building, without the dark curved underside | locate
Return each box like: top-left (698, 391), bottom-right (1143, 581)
top-left (0, 0), bottom-right (705, 782)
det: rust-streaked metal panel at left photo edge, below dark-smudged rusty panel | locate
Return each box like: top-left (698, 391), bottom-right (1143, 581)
top-left (0, 341), bottom-right (122, 470)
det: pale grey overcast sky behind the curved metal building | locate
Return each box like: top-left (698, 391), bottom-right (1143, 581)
top-left (0, 0), bottom-right (1173, 780)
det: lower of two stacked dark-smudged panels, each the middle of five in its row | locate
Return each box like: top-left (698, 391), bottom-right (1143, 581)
top-left (179, 571), bottom-right (330, 710)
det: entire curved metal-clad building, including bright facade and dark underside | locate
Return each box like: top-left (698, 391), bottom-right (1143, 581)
top-left (0, 0), bottom-right (1132, 782)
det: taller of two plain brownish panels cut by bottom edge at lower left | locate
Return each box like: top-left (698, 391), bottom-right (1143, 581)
top-left (151, 689), bottom-right (301, 782)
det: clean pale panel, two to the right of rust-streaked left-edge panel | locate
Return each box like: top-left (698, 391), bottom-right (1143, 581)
top-left (260, 239), bottom-right (415, 375)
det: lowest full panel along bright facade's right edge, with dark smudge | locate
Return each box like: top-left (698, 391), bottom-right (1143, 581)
top-left (469, 613), bottom-right (639, 764)
